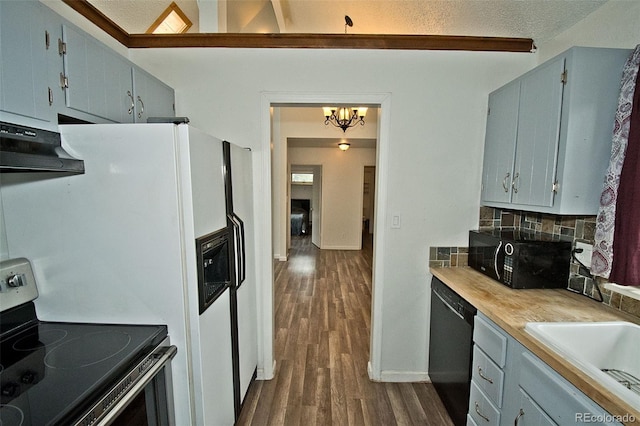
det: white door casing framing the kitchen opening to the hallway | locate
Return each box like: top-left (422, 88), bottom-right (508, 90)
top-left (255, 92), bottom-right (391, 381)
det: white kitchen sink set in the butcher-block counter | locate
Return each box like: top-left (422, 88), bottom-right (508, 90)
top-left (525, 321), bottom-right (640, 408)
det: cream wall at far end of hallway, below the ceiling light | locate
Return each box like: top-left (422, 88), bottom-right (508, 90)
top-left (289, 147), bottom-right (376, 250)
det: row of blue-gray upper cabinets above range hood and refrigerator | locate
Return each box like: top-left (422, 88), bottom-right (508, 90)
top-left (0, 0), bottom-right (175, 130)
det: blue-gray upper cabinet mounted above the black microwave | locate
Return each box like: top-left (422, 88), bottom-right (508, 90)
top-left (481, 47), bottom-right (631, 215)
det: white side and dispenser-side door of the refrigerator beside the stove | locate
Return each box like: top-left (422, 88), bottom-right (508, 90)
top-left (0, 124), bottom-right (250, 426)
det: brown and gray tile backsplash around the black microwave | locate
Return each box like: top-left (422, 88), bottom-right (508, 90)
top-left (429, 207), bottom-right (640, 317)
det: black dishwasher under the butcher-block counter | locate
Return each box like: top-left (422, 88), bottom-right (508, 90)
top-left (429, 277), bottom-right (477, 426)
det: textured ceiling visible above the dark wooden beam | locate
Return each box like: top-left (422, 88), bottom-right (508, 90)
top-left (89, 0), bottom-right (608, 42)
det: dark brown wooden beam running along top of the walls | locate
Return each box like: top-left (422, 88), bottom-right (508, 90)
top-left (62, 0), bottom-right (535, 52)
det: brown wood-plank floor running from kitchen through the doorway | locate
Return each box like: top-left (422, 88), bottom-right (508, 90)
top-left (236, 234), bottom-right (452, 426)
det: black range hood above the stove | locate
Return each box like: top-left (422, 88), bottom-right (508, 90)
top-left (0, 122), bottom-right (84, 173)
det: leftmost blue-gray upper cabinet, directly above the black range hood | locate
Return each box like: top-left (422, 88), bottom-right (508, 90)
top-left (0, 1), bottom-right (60, 128)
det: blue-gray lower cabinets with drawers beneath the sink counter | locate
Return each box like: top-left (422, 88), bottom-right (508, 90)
top-left (467, 313), bottom-right (620, 426)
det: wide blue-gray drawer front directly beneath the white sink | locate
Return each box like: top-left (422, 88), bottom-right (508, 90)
top-left (520, 352), bottom-right (620, 425)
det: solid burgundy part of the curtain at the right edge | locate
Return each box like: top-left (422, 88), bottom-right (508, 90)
top-left (609, 71), bottom-right (640, 286)
